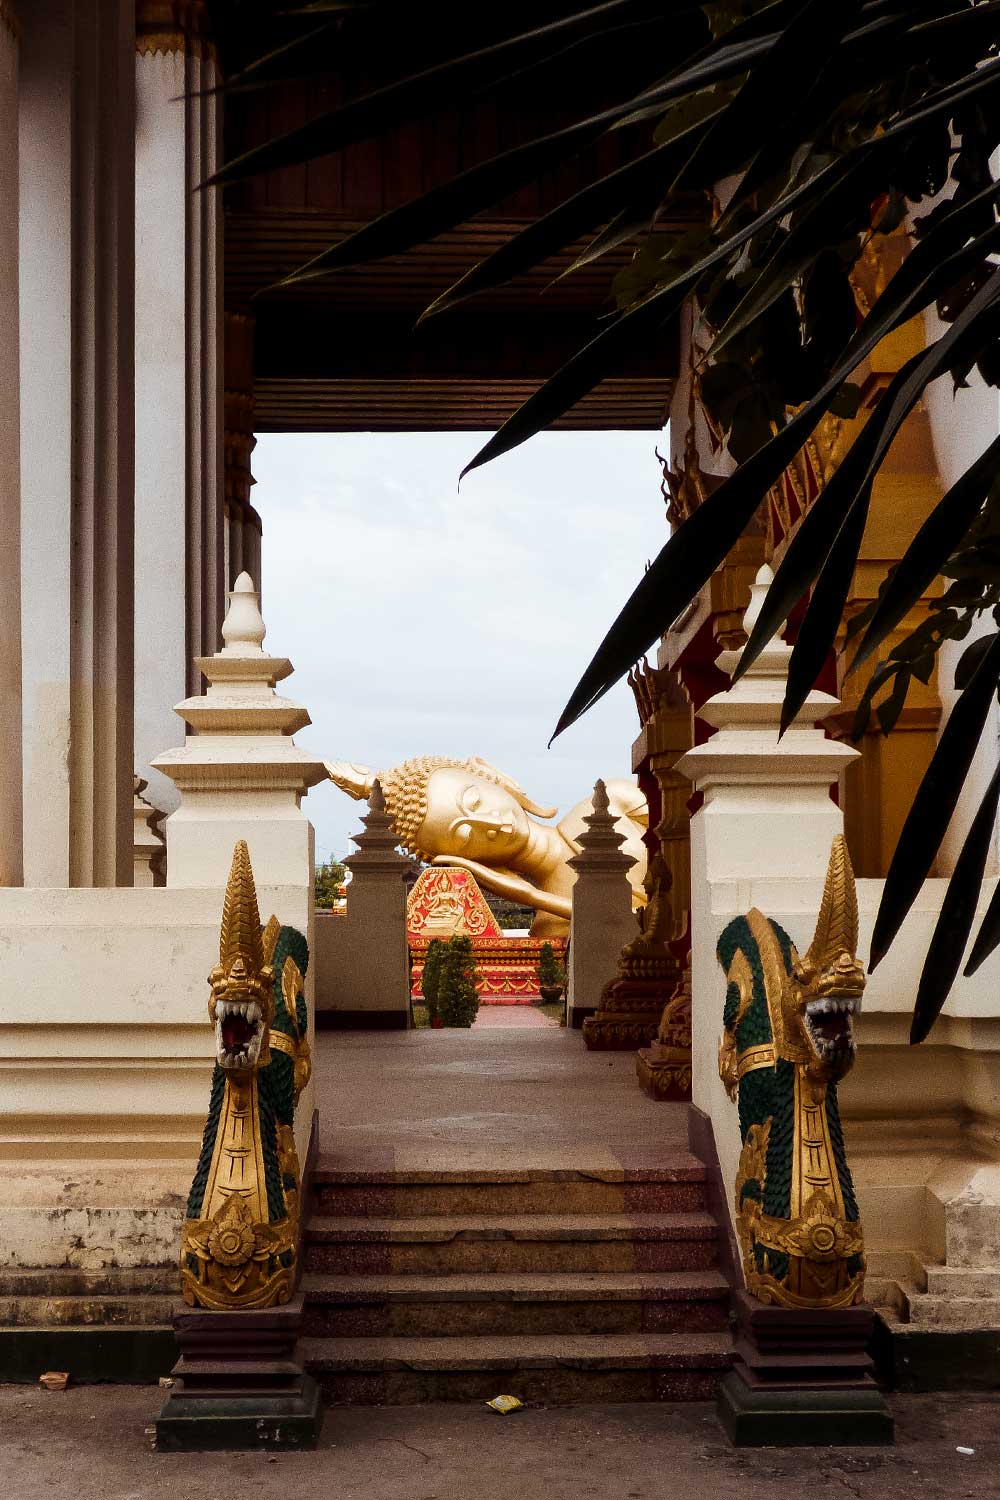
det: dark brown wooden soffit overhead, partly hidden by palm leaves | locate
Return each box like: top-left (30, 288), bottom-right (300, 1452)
top-left (225, 6), bottom-right (703, 432)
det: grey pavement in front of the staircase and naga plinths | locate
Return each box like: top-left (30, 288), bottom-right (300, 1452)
top-left (0, 1386), bottom-right (1000, 1500)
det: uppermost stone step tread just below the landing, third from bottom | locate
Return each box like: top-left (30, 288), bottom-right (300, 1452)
top-left (306, 1214), bottom-right (718, 1245)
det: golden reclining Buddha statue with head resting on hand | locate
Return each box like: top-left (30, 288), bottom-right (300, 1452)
top-left (327, 756), bottom-right (649, 938)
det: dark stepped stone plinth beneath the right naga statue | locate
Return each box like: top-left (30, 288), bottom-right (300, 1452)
top-left (718, 1292), bottom-right (894, 1448)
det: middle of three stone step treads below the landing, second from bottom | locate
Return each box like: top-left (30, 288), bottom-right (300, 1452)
top-left (301, 1271), bottom-right (730, 1304)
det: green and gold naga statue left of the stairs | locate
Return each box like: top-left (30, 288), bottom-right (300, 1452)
top-left (180, 840), bottom-right (312, 1311)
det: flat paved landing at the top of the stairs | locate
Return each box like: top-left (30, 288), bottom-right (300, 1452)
top-left (316, 1032), bottom-right (687, 1172)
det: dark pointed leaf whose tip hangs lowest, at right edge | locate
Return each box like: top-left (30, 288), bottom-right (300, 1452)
top-left (910, 767), bottom-right (1000, 1044)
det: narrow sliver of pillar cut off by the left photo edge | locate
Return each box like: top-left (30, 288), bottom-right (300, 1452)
top-left (0, 0), bottom-right (22, 885)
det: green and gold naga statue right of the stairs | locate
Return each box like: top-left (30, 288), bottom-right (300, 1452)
top-left (717, 836), bottom-right (865, 1308)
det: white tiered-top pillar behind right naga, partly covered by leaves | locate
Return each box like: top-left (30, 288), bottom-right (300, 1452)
top-left (676, 566), bottom-right (858, 1212)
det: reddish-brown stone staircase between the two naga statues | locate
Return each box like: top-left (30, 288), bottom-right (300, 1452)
top-left (303, 1154), bottom-right (730, 1404)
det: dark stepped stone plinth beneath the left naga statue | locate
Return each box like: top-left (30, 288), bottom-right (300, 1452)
top-left (156, 1293), bottom-right (322, 1452)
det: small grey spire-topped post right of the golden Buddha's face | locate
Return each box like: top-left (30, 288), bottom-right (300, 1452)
top-left (567, 782), bottom-right (639, 1026)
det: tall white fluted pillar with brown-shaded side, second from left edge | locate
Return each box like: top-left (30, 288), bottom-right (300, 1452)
top-left (18, 0), bottom-right (135, 887)
